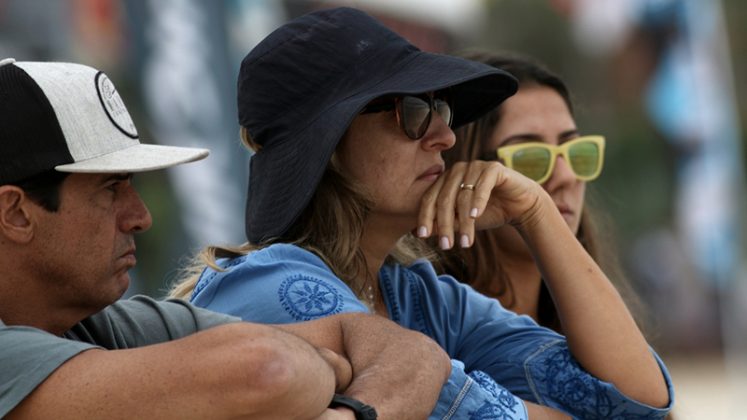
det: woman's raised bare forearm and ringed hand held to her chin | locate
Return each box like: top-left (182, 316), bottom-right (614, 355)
top-left (419, 161), bottom-right (670, 407)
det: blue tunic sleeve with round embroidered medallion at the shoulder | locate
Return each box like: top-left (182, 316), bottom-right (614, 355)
top-left (191, 244), bottom-right (370, 324)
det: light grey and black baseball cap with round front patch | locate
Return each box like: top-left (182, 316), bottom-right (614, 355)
top-left (0, 58), bottom-right (209, 185)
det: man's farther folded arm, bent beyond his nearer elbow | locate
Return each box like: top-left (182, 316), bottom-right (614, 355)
top-left (278, 313), bottom-right (451, 419)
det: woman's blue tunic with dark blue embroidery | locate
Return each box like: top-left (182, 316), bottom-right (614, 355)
top-left (191, 244), bottom-right (673, 419)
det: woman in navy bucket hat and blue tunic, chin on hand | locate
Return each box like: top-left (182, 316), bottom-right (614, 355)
top-left (172, 8), bottom-right (671, 418)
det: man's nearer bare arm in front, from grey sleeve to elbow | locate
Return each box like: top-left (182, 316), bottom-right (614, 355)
top-left (7, 323), bottom-right (335, 419)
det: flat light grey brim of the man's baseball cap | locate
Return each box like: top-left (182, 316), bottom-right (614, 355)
top-left (55, 144), bottom-right (210, 173)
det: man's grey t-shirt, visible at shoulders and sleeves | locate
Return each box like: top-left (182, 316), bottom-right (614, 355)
top-left (0, 296), bottom-right (239, 418)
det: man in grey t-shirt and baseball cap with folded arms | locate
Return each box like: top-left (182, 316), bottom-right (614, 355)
top-left (0, 59), bottom-right (449, 418)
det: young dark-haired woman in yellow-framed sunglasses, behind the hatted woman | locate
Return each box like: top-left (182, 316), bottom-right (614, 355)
top-left (434, 51), bottom-right (640, 332)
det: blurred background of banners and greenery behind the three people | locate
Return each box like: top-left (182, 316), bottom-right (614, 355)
top-left (0, 0), bottom-right (747, 419)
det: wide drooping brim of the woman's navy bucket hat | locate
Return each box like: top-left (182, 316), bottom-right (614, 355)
top-left (246, 51), bottom-right (518, 243)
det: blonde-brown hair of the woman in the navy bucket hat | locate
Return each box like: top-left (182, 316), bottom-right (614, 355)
top-left (169, 127), bottom-right (434, 299)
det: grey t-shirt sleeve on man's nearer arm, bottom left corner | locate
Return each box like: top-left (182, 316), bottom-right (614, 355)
top-left (0, 322), bottom-right (96, 418)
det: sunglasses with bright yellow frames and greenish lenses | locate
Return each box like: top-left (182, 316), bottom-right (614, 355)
top-left (496, 136), bottom-right (604, 184)
